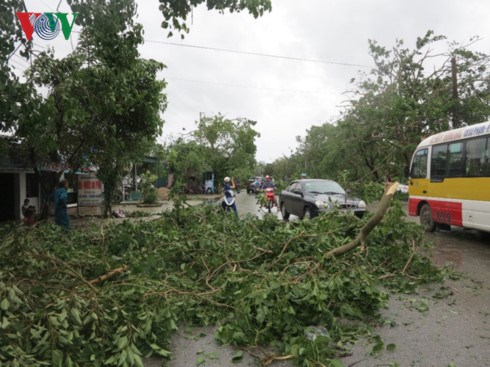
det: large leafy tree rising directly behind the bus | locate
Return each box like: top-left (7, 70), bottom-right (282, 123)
top-left (356, 31), bottom-right (490, 169)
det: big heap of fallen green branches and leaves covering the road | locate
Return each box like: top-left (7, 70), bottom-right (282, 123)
top-left (0, 205), bottom-right (442, 367)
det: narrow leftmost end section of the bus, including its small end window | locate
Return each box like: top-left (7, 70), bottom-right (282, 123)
top-left (408, 148), bottom-right (429, 216)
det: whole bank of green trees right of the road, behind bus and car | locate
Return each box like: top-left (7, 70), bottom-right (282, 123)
top-left (270, 31), bottom-right (490, 185)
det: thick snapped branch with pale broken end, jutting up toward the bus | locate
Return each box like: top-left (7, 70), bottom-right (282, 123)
top-left (325, 182), bottom-right (398, 259)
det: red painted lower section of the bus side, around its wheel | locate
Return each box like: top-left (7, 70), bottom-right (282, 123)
top-left (408, 199), bottom-right (463, 227)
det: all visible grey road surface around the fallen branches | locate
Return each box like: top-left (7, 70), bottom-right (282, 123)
top-left (145, 192), bottom-right (490, 367)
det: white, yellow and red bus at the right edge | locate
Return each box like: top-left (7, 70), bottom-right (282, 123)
top-left (408, 121), bottom-right (490, 232)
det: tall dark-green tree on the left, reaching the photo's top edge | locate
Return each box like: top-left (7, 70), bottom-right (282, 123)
top-left (69, 0), bottom-right (166, 215)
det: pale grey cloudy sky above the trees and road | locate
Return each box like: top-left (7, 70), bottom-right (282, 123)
top-left (13, 0), bottom-right (490, 162)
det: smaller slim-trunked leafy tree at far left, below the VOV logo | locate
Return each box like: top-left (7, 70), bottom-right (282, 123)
top-left (16, 52), bottom-right (90, 218)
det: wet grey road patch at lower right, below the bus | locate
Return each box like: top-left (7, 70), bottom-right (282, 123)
top-left (343, 227), bottom-right (490, 367)
